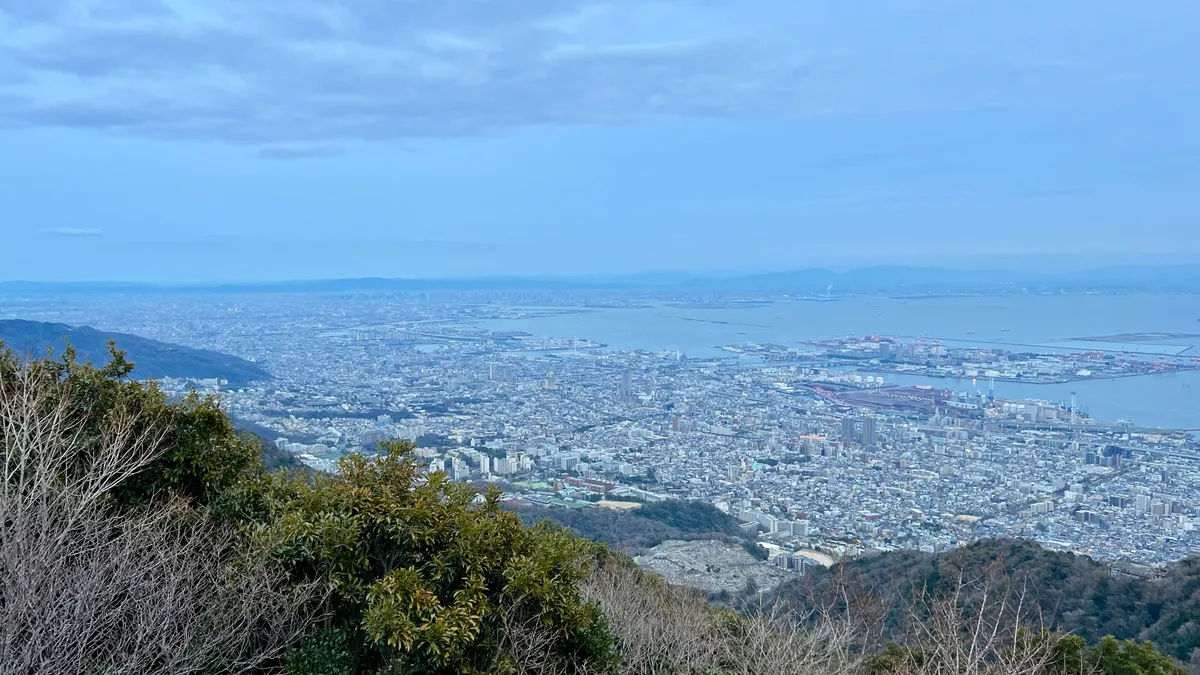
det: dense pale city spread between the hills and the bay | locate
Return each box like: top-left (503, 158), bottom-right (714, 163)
top-left (0, 293), bottom-right (1200, 573)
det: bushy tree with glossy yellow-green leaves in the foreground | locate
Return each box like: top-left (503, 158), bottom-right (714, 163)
top-left (258, 442), bottom-right (616, 674)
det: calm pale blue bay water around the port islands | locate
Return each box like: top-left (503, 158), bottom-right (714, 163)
top-left (481, 294), bottom-right (1200, 429)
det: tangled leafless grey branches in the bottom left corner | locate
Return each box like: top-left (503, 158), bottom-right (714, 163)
top-left (0, 368), bottom-right (313, 675)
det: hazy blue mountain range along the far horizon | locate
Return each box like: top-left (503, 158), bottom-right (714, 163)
top-left (0, 264), bottom-right (1200, 295)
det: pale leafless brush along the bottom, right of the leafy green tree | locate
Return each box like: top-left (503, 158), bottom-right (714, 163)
top-left (586, 557), bottom-right (1094, 675)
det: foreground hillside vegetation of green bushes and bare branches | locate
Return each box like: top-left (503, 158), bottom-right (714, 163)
top-left (0, 341), bottom-right (1183, 675)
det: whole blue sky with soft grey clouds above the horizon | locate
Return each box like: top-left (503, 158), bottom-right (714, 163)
top-left (0, 0), bottom-right (1200, 282)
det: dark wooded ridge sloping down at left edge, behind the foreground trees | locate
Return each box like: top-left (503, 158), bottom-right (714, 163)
top-left (0, 319), bottom-right (271, 384)
